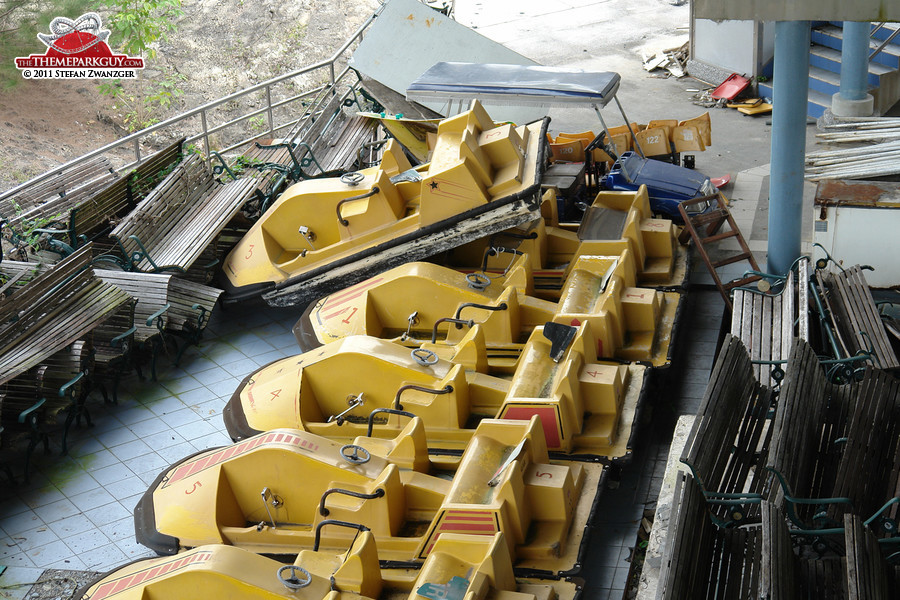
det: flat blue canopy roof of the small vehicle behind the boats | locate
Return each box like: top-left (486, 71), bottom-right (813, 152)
top-left (406, 62), bottom-right (621, 107)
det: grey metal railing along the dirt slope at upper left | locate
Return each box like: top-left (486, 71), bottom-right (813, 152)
top-left (0, 6), bottom-right (382, 206)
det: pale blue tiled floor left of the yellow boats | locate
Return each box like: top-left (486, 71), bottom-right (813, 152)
top-left (0, 310), bottom-right (299, 598)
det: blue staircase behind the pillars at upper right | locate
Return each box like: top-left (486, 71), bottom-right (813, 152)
top-left (759, 21), bottom-right (900, 117)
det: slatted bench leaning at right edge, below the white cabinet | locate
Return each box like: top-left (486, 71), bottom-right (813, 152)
top-left (816, 265), bottom-right (900, 369)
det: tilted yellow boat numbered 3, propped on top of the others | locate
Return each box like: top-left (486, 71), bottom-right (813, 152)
top-left (221, 102), bottom-right (548, 306)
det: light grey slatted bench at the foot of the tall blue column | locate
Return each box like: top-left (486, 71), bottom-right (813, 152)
top-left (731, 257), bottom-right (810, 386)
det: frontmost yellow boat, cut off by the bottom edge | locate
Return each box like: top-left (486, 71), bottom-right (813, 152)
top-left (74, 530), bottom-right (576, 600)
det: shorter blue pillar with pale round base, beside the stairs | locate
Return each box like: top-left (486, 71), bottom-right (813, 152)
top-left (831, 21), bottom-right (875, 117)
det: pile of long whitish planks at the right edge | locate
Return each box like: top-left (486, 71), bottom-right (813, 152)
top-left (806, 117), bottom-right (900, 181)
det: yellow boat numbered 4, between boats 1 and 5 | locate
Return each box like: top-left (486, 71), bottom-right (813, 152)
top-left (223, 322), bottom-right (647, 463)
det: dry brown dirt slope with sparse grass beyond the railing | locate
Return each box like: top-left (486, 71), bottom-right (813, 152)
top-left (0, 0), bottom-right (378, 190)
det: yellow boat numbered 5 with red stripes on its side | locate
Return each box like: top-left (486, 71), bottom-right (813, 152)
top-left (135, 417), bottom-right (602, 577)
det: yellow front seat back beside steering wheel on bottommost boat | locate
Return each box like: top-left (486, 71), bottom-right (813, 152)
top-left (294, 531), bottom-right (382, 598)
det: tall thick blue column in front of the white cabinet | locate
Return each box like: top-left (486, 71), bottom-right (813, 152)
top-left (767, 21), bottom-right (809, 274)
